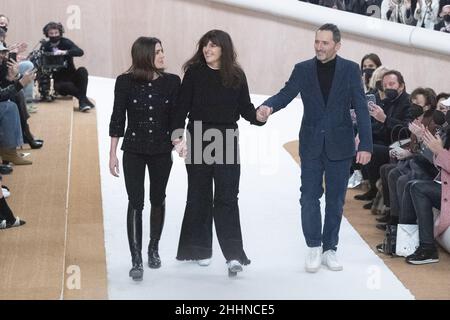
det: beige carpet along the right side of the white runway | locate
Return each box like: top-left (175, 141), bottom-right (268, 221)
top-left (284, 141), bottom-right (450, 300)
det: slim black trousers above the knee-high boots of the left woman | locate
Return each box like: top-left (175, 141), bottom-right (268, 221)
top-left (123, 151), bottom-right (172, 211)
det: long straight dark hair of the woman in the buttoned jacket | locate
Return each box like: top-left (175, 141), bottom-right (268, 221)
top-left (127, 37), bottom-right (164, 81)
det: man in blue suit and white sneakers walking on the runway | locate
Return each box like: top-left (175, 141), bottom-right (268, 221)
top-left (258, 24), bottom-right (372, 272)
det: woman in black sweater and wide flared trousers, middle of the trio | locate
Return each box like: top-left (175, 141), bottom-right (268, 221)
top-left (174, 30), bottom-right (264, 275)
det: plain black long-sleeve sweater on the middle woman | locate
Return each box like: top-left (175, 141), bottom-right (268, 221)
top-left (172, 64), bottom-right (264, 129)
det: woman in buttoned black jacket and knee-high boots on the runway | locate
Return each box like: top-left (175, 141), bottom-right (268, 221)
top-left (109, 37), bottom-right (181, 281)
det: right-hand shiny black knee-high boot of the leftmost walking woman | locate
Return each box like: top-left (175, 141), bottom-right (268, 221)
top-left (148, 203), bottom-right (166, 269)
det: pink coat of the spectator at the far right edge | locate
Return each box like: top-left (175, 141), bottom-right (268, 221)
top-left (434, 150), bottom-right (450, 237)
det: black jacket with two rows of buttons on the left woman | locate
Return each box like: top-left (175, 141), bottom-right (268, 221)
top-left (109, 73), bottom-right (181, 154)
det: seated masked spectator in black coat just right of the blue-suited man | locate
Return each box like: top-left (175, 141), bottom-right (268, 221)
top-left (355, 70), bottom-right (411, 201)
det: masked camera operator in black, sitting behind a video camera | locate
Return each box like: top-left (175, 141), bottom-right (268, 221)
top-left (41, 22), bottom-right (94, 112)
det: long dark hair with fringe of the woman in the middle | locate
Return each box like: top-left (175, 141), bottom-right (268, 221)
top-left (183, 30), bottom-right (244, 88)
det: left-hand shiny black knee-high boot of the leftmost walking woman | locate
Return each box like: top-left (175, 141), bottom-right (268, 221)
top-left (127, 204), bottom-right (144, 281)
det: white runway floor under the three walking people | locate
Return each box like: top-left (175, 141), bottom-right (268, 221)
top-left (88, 77), bottom-right (414, 300)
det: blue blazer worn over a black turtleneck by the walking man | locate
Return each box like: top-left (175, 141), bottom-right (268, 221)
top-left (264, 56), bottom-right (373, 160)
